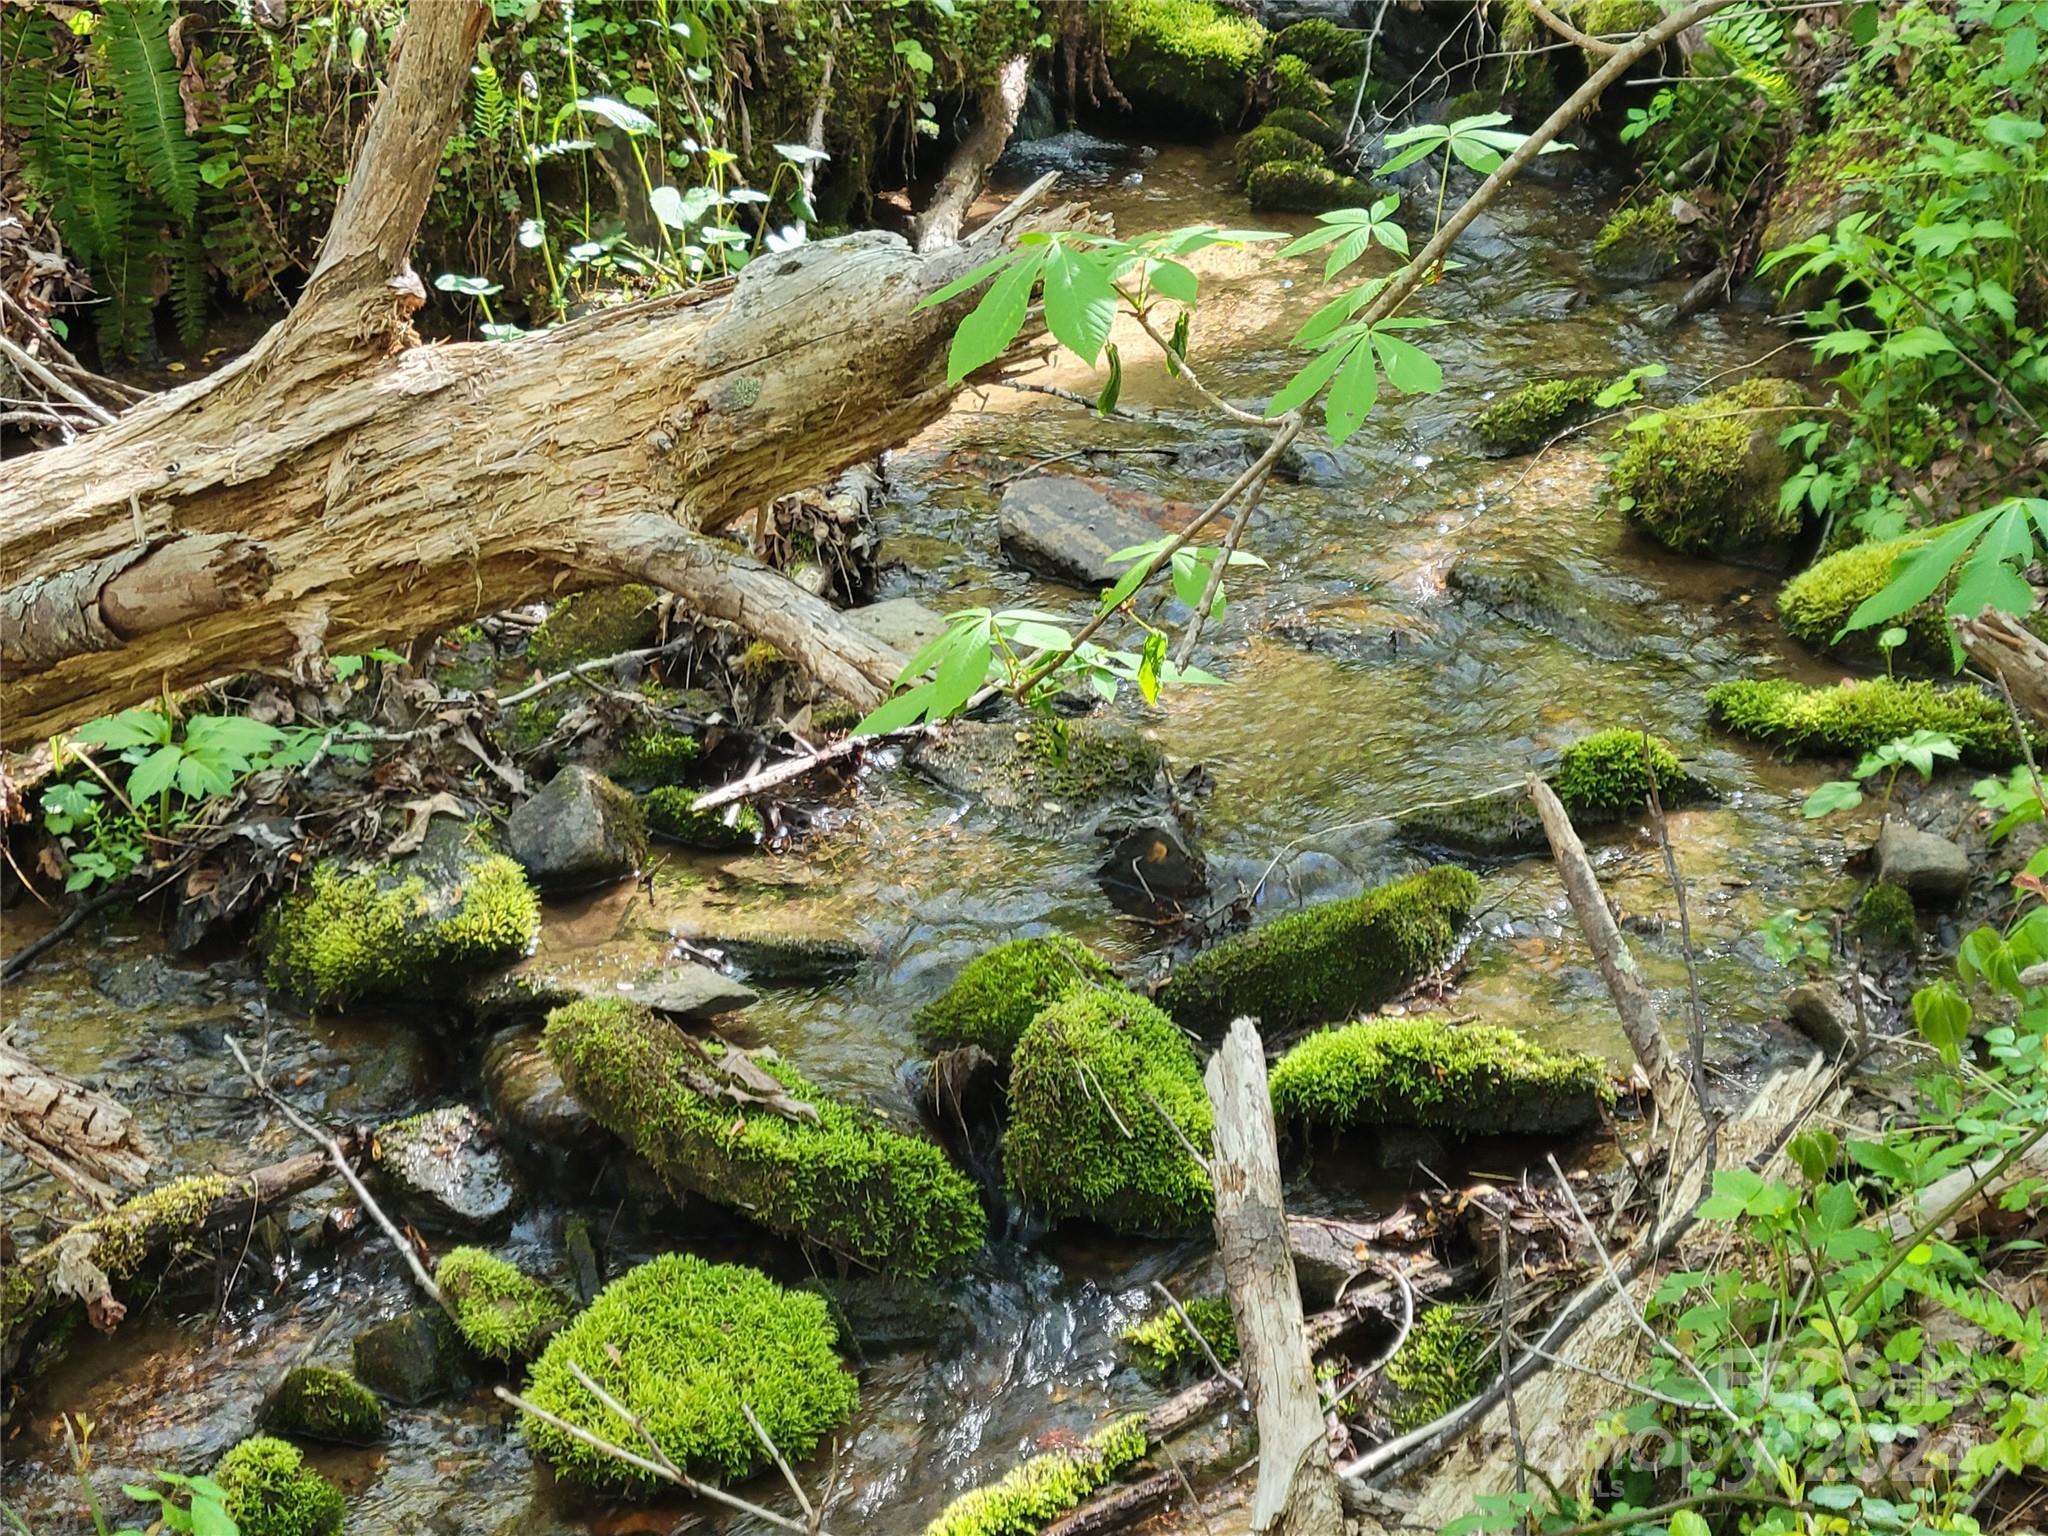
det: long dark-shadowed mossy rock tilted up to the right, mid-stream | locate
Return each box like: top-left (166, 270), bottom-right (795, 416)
top-left (1159, 864), bottom-right (1479, 1034)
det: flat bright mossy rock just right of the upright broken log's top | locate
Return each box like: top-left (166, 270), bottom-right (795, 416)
top-left (1270, 1018), bottom-right (1614, 1137)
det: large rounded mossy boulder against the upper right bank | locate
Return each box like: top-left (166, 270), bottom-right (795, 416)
top-left (1614, 379), bottom-right (1806, 559)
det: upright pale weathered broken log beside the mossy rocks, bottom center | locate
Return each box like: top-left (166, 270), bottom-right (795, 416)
top-left (1204, 1018), bottom-right (1343, 1536)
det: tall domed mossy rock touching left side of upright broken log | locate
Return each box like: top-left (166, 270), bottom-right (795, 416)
top-left (1004, 987), bottom-right (1214, 1233)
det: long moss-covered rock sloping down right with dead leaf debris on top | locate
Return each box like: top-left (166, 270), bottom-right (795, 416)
top-left (541, 997), bottom-right (987, 1276)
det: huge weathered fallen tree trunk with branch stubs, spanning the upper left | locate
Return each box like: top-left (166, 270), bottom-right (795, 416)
top-left (0, 0), bottom-right (1065, 748)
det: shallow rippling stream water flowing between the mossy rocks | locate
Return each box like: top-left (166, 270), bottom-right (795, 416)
top-left (6, 141), bottom-right (1839, 1536)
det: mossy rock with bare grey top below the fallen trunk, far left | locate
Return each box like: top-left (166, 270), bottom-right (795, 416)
top-left (260, 821), bottom-right (541, 1010)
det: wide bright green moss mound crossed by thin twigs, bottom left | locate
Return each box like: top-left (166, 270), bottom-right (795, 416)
top-left (522, 1253), bottom-right (860, 1493)
